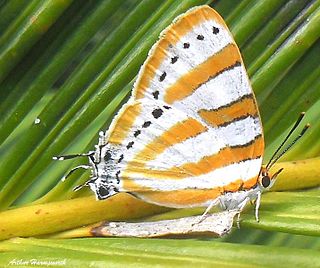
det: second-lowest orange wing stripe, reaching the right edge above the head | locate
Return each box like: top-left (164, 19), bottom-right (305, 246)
top-left (170, 136), bottom-right (263, 177)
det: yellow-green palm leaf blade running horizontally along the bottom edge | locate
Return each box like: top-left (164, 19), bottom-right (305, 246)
top-left (0, 238), bottom-right (320, 267)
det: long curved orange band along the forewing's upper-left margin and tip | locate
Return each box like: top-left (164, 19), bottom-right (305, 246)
top-left (135, 6), bottom-right (228, 99)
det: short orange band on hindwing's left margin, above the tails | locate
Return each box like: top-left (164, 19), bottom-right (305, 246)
top-left (108, 103), bottom-right (141, 144)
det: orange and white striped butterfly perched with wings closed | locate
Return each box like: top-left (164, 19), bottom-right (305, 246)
top-left (56, 6), bottom-right (308, 220)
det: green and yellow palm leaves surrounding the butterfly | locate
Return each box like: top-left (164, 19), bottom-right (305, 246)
top-left (0, 0), bottom-right (320, 267)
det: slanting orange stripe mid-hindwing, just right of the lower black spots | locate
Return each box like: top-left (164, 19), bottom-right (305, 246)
top-left (127, 118), bottom-right (207, 172)
